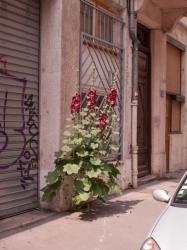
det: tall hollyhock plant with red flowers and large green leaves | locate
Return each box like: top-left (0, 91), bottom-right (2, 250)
top-left (42, 83), bottom-right (120, 205)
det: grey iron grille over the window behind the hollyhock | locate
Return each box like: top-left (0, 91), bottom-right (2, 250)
top-left (80, 0), bottom-right (124, 158)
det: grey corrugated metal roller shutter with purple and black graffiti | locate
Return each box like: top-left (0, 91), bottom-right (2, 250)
top-left (0, 0), bottom-right (40, 218)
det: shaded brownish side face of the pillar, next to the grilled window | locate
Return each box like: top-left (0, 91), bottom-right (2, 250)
top-left (61, 0), bottom-right (80, 144)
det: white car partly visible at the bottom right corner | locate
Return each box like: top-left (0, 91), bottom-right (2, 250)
top-left (141, 172), bottom-right (187, 250)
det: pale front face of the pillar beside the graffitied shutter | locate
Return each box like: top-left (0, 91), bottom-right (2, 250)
top-left (40, 0), bottom-right (62, 191)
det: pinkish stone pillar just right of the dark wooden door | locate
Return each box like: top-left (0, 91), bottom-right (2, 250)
top-left (151, 30), bottom-right (166, 176)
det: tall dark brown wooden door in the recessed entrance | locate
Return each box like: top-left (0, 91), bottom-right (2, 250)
top-left (137, 25), bottom-right (151, 178)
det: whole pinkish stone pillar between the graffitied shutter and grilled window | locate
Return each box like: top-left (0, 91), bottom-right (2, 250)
top-left (40, 0), bottom-right (80, 210)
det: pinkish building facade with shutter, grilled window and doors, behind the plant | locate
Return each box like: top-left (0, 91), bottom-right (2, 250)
top-left (0, 0), bottom-right (187, 218)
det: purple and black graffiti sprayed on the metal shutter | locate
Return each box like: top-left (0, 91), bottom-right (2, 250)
top-left (0, 54), bottom-right (38, 188)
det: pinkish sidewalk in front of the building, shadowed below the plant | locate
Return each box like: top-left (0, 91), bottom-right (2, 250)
top-left (0, 175), bottom-right (183, 250)
